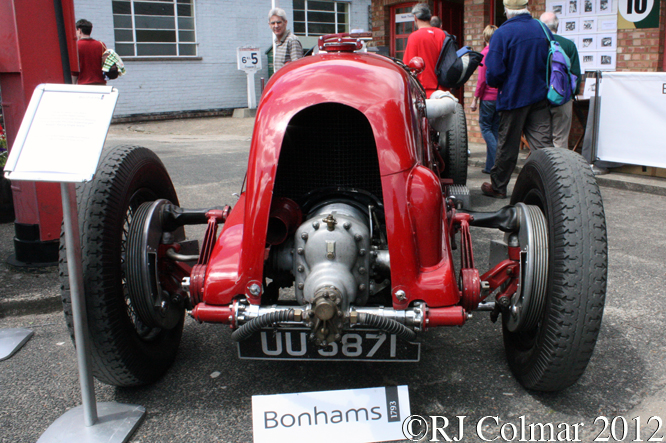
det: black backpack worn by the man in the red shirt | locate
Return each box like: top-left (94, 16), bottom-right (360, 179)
top-left (435, 32), bottom-right (483, 88)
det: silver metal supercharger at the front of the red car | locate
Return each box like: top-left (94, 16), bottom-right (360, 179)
top-left (272, 202), bottom-right (376, 344)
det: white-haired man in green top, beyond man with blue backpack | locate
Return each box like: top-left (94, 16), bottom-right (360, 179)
top-left (540, 12), bottom-right (580, 148)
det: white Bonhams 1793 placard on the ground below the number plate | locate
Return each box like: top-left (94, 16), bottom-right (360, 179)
top-left (252, 386), bottom-right (410, 443)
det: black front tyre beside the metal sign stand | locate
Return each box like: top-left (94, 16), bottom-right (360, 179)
top-left (60, 146), bottom-right (184, 386)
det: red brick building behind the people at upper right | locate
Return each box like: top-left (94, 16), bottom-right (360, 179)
top-left (372, 0), bottom-right (666, 143)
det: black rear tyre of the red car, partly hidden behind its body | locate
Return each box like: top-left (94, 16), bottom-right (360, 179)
top-left (440, 103), bottom-right (469, 185)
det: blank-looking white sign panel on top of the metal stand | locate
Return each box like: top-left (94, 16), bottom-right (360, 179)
top-left (5, 84), bottom-right (118, 183)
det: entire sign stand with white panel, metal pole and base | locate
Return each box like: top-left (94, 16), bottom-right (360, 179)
top-left (5, 84), bottom-right (146, 443)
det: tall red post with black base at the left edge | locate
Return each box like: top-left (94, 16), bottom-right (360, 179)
top-left (0, 0), bottom-right (78, 266)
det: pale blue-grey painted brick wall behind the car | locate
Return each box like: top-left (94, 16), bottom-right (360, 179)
top-left (74, 0), bottom-right (370, 117)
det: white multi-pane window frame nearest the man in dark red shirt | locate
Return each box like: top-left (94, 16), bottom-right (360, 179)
top-left (113, 0), bottom-right (199, 59)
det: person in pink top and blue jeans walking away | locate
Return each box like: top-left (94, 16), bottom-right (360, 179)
top-left (471, 25), bottom-right (499, 174)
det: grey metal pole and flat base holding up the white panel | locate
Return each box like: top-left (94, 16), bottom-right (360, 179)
top-left (37, 183), bottom-right (146, 443)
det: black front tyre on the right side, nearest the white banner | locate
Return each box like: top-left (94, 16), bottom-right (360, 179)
top-left (503, 148), bottom-right (608, 391)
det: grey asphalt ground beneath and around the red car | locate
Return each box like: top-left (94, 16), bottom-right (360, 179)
top-left (0, 118), bottom-right (666, 442)
